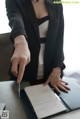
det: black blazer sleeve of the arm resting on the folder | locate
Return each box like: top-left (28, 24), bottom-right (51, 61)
top-left (54, 4), bottom-right (65, 69)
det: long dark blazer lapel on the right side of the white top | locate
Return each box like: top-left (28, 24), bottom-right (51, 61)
top-left (44, 0), bottom-right (58, 63)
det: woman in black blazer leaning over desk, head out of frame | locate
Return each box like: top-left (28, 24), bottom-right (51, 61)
top-left (6, 0), bottom-right (69, 92)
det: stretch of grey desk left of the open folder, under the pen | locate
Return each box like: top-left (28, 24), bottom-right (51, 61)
top-left (0, 81), bottom-right (27, 119)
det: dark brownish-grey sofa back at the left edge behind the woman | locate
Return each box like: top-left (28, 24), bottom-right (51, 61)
top-left (0, 33), bottom-right (13, 81)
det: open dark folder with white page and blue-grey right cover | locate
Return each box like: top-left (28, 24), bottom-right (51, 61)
top-left (21, 78), bottom-right (80, 119)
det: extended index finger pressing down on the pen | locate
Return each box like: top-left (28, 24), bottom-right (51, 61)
top-left (17, 60), bottom-right (26, 83)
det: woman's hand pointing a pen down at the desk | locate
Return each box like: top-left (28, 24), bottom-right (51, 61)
top-left (11, 35), bottom-right (30, 83)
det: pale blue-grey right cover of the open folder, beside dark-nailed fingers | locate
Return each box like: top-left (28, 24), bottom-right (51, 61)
top-left (59, 77), bottom-right (80, 111)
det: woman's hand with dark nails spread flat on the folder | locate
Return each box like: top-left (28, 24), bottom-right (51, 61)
top-left (44, 74), bottom-right (70, 93)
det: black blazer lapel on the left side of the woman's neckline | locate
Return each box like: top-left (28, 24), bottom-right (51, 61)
top-left (18, 0), bottom-right (40, 45)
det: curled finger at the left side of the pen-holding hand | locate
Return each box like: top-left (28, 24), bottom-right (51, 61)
top-left (11, 58), bottom-right (19, 76)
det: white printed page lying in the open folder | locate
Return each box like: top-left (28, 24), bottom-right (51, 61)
top-left (24, 84), bottom-right (67, 119)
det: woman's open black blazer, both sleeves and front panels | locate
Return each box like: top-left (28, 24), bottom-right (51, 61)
top-left (6, 0), bottom-right (65, 82)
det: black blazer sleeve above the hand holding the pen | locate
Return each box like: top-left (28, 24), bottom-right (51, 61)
top-left (6, 0), bottom-right (27, 42)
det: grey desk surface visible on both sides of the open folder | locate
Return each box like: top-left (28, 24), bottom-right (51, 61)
top-left (0, 81), bottom-right (80, 119)
